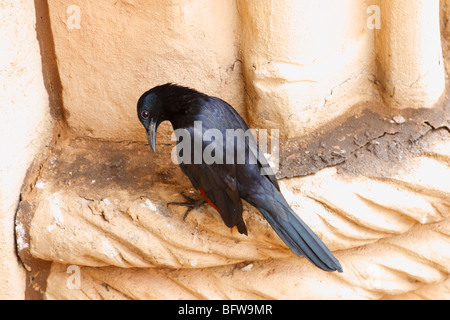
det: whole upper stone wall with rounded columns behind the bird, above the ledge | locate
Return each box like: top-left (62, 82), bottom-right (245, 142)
top-left (44, 0), bottom-right (445, 141)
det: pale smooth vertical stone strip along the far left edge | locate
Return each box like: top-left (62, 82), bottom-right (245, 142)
top-left (0, 1), bottom-right (51, 299)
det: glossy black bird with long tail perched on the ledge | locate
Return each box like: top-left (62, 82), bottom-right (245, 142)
top-left (137, 83), bottom-right (342, 272)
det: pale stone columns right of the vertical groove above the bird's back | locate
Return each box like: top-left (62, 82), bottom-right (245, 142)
top-left (238, 0), bottom-right (445, 137)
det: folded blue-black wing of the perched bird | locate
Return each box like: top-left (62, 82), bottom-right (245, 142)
top-left (180, 97), bottom-right (279, 234)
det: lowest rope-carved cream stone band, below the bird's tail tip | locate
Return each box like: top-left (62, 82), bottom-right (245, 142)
top-left (47, 222), bottom-right (449, 299)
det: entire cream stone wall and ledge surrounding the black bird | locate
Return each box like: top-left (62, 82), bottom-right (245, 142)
top-left (0, 0), bottom-right (450, 299)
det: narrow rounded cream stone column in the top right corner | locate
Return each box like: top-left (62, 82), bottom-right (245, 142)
top-left (375, 0), bottom-right (445, 108)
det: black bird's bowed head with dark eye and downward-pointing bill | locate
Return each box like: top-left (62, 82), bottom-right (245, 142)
top-left (137, 90), bottom-right (165, 151)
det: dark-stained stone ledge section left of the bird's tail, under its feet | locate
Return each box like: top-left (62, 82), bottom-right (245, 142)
top-left (27, 141), bottom-right (296, 268)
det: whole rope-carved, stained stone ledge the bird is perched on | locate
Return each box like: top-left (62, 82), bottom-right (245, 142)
top-left (19, 110), bottom-right (450, 299)
